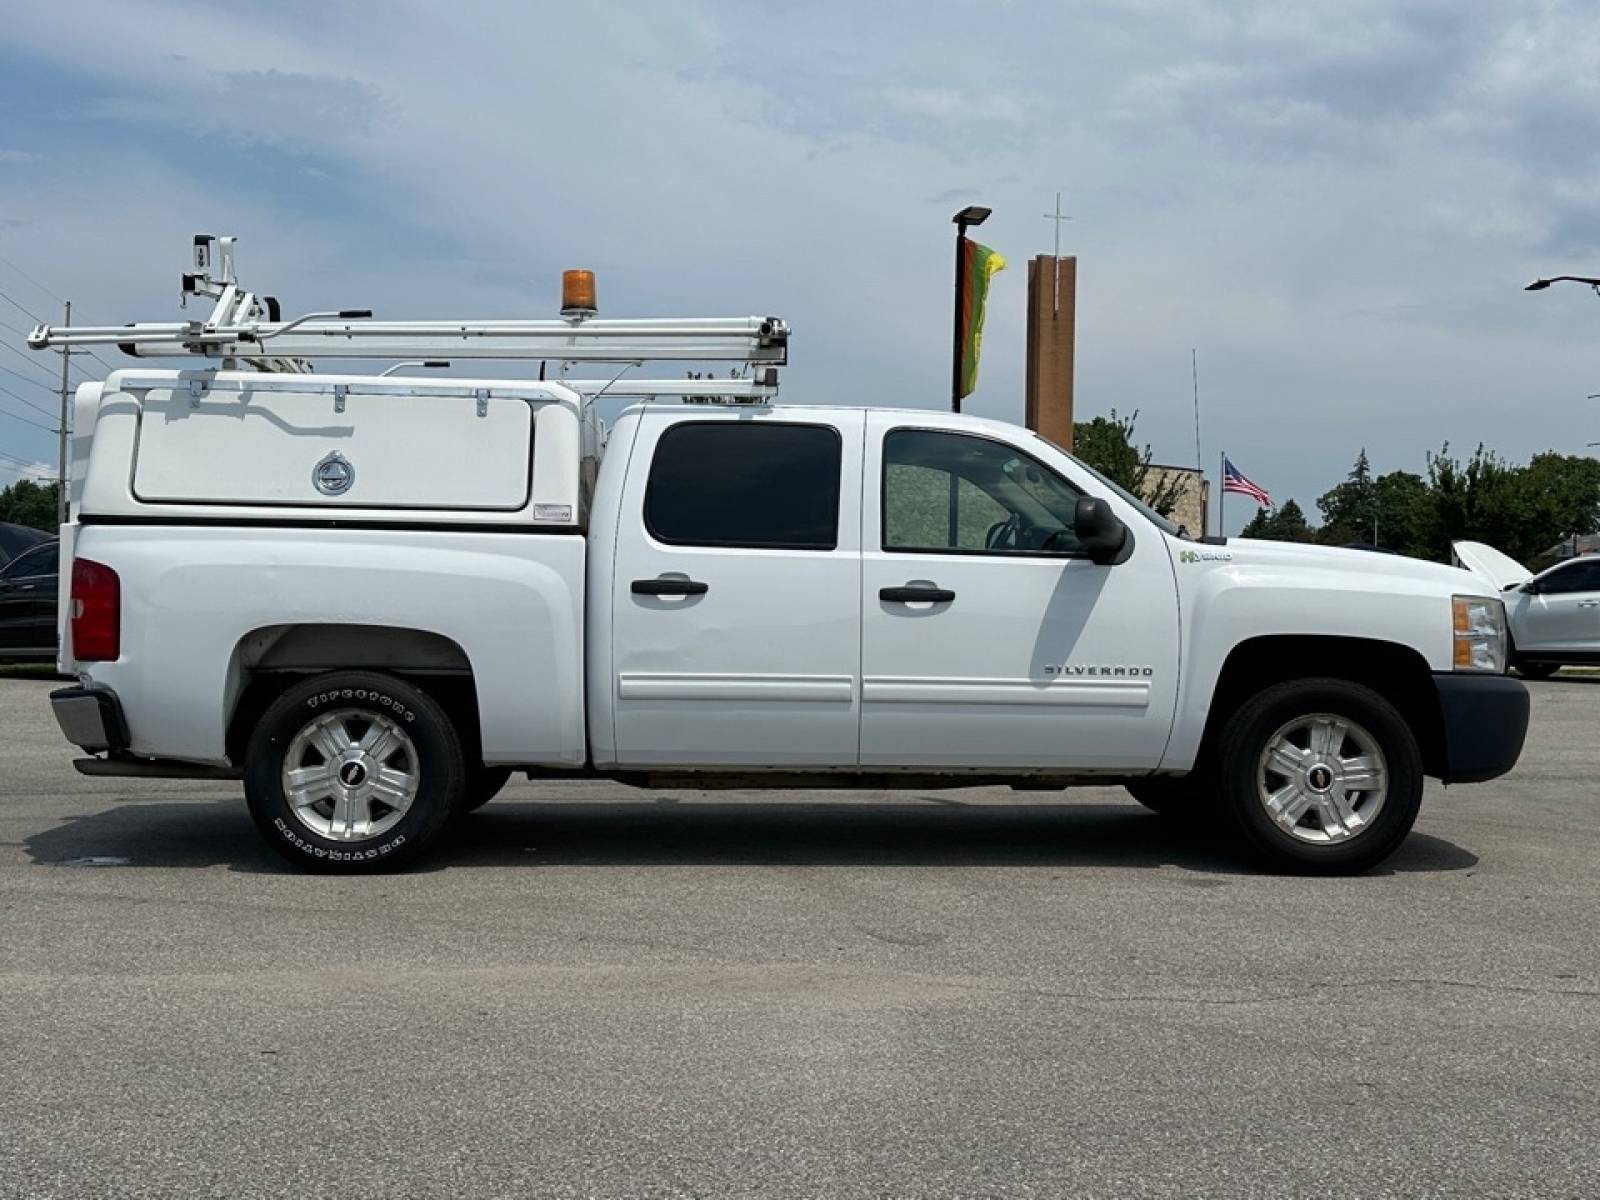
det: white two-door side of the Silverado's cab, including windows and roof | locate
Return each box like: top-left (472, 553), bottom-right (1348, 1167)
top-left (589, 406), bottom-right (1179, 774)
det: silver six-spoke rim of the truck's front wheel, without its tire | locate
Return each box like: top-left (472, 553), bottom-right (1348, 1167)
top-left (1256, 712), bottom-right (1389, 845)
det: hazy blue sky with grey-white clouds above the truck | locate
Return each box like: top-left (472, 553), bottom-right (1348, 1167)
top-left (0, 0), bottom-right (1600, 531)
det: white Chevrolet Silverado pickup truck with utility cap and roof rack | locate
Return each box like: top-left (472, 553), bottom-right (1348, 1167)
top-left (32, 240), bottom-right (1528, 872)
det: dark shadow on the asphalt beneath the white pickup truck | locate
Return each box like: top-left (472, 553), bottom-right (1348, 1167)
top-left (24, 797), bottom-right (1478, 875)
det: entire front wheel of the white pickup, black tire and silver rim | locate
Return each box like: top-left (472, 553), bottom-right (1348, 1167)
top-left (1218, 678), bottom-right (1422, 875)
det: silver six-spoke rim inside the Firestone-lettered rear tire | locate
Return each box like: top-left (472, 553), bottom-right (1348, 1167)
top-left (283, 709), bottom-right (421, 842)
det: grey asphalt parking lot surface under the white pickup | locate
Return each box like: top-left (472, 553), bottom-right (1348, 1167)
top-left (0, 677), bottom-right (1600, 1198)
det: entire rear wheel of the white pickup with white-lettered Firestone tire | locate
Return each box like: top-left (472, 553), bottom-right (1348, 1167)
top-left (245, 670), bottom-right (466, 874)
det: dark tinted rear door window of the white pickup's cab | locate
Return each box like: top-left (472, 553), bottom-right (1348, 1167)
top-left (645, 421), bottom-right (842, 550)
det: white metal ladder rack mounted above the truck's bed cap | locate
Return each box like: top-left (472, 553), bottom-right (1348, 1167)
top-left (27, 234), bottom-right (789, 387)
